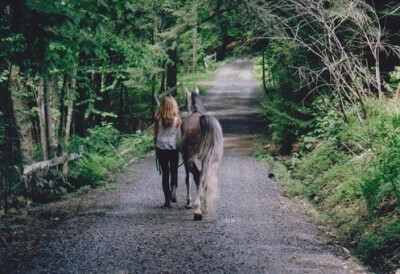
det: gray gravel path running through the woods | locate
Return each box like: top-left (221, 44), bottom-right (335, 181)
top-left (17, 60), bottom-right (362, 273)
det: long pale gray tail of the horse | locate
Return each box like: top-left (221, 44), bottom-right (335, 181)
top-left (199, 115), bottom-right (224, 213)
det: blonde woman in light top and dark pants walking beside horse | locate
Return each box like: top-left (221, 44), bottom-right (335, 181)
top-left (154, 97), bottom-right (182, 207)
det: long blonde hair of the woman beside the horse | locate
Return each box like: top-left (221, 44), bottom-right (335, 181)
top-left (154, 96), bottom-right (182, 128)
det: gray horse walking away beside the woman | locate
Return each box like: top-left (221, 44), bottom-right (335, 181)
top-left (180, 87), bottom-right (223, 220)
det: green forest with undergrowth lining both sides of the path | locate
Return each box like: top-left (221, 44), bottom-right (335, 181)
top-left (0, 0), bottom-right (400, 273)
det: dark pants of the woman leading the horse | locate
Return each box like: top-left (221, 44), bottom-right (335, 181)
top-left (156, 148), bottom-right (179, 203)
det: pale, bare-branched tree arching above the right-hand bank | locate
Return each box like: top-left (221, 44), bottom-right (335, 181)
top-left (247, 0), bottom-right (399, 116)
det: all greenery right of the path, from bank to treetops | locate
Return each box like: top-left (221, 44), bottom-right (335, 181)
top-left (253, 1), bottom-right (400, 272)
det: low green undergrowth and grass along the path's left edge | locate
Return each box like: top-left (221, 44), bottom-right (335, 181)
top-left (0, 62), bottom-right (222, 212)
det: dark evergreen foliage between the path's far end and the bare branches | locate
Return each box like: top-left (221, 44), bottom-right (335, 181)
top-left (257, 37), bottom-right (328, 154)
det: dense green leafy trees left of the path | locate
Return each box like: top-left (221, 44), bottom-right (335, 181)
top-left (0, 0), bottom-right (241, 206)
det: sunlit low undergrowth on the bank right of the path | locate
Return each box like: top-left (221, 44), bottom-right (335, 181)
top-left (256, 93), bottom-right (400, 273)
